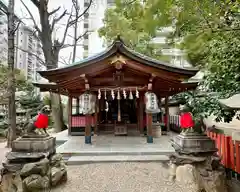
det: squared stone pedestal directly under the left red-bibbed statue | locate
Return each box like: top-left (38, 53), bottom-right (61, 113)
top-left (12, 135), bottom-right (56, 154)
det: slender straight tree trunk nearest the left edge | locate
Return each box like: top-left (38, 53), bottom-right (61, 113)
top-left (7, 0), bottom-right (16, 147)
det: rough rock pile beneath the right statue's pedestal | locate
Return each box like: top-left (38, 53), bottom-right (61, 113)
top-left (169, 154), bottom-right (227, 192)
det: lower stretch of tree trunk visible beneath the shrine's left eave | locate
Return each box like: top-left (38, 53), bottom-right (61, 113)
top-left (50, 93), bottom-right (64, 133)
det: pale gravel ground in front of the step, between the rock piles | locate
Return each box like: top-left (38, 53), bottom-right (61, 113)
top-left (51, 162), bottom-right (188, 192)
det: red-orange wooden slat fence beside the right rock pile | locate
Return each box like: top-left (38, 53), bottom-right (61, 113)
top-left (207, 131), bottom-right (240, 180)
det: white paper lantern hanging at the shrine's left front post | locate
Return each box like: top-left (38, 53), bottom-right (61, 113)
top-left (79, 92), bottom-right (96, 115)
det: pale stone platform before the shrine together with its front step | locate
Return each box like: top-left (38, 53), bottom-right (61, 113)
top-left (56, 132), bottom-right (174, 165)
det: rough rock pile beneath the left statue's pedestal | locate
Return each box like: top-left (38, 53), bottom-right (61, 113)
top-left (0, 154), bottom-right (67, 192)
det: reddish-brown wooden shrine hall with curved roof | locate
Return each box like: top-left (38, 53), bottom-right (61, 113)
top-left (34, 38), bottom-right (198, 143)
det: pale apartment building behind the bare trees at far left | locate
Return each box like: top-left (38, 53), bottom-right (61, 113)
top-left (0, 0), bottom-right (45, 81)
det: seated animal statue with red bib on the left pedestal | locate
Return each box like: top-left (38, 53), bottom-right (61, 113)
top-left (25, 105), bottom-right (51, 135)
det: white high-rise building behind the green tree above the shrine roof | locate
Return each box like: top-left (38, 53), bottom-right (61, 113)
top-left (83, 0), bottom-right (191, 67)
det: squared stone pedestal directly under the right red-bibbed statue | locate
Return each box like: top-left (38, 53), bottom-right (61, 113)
top-left (171, 133), bottom-right (217, 154)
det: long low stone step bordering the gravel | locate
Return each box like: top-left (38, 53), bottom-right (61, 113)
top-left (66, 155), bottom-right (169, 165)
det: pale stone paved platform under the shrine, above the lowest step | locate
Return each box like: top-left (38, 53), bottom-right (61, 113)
top-left (56, 132), bottom-right (174, 155)
